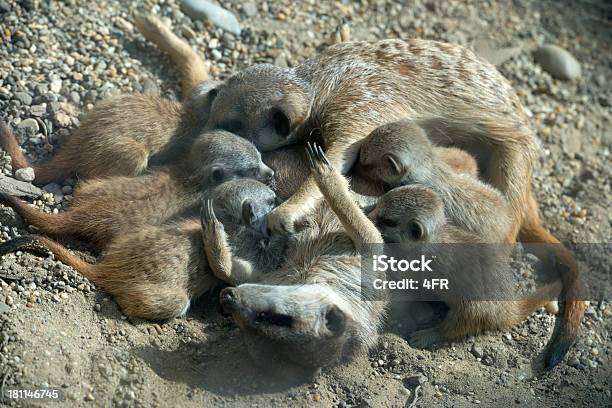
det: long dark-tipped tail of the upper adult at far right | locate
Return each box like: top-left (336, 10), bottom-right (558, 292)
top-left (519, 198), bottom-right (586, 368)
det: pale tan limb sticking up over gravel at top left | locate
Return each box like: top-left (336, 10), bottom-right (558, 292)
top-left (134, 14), bottom-right (210, 98)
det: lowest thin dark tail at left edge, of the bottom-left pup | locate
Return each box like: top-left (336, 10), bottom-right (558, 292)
top-left (0, 235), bottom-right (98, 285)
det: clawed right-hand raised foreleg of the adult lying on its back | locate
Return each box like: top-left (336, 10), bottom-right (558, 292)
top-left (307, 144), bottom-right (383, 248)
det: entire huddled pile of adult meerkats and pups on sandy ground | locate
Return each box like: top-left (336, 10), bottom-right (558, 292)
top-left (0, 15), bottom-right (584, 373)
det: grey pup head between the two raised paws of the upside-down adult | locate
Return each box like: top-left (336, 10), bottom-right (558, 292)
top-left (210, 179), bottom-right (279, 235)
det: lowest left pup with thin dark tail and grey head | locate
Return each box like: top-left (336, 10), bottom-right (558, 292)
top-left (0, 179), bottom-right (284, 321)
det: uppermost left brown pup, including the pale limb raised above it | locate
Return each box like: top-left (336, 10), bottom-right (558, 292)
top-left (0, 15), bottom-right (220, 185)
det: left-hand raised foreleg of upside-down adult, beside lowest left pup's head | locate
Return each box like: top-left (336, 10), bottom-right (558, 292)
top-left (200, 200), bottom-right (255, 286)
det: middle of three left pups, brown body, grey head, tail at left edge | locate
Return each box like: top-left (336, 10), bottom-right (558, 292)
top-left (0, 131), bottom-right (274, 249)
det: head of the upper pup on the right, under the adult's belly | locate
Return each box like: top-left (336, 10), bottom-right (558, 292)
top-left (359, 120), bottom-right (435, 188)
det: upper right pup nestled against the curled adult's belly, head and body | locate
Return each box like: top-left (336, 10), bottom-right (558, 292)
top-left (358, 120), bottom-right (514, 244)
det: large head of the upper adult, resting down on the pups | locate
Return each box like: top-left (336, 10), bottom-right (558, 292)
top-left (206, 64), bottom-right (310, 151)
